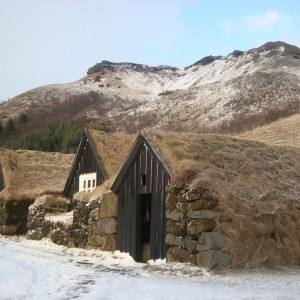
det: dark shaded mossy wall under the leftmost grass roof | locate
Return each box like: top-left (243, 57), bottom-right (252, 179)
top-left (0, 198), bottom-right (33, 235)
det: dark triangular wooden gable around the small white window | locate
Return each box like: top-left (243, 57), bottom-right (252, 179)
top-left (63, 129), bottom-right (108, 198)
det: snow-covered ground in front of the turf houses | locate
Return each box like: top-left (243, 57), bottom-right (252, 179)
top-left (0, 236), bottom-right (300, 300)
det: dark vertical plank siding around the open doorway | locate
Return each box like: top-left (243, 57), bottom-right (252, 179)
top-left (117, 143), bottom-right (170, 260)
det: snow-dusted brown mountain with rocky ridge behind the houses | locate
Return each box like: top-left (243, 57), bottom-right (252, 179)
top-left (0, 42), bottom-right (300, 132)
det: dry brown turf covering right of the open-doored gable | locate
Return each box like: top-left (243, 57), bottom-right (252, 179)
top-left (151, 133), bottom-right (300, 267)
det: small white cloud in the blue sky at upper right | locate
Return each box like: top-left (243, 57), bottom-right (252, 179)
top-left (243, 11), bottom-right (290, 31)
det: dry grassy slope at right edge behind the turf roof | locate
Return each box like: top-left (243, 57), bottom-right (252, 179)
top-left (238, 114), bottom-right (300, 148)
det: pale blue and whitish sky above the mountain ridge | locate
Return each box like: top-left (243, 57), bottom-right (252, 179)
top-left (0, 0), bottom-right (300, 100)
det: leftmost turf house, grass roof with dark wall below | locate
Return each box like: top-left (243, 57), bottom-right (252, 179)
top-left (0, 149), bottom-right (73, 235)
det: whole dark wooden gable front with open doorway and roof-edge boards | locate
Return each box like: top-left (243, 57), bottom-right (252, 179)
top-left (112, 131), bottom-right (173, 261)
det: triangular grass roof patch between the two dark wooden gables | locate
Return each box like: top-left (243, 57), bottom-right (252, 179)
top-left (90, 130), bottom-right (137, 178)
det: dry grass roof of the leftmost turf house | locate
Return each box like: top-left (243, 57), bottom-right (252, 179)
top-left (0, 149), bottom-right (74, 200)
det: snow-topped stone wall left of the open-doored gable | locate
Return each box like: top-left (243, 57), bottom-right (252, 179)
top-left (26, 192), bottom-right (117, 251)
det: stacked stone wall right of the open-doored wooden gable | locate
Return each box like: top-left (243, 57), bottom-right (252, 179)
top-left (166, 186), bottom-right (231, 269)
